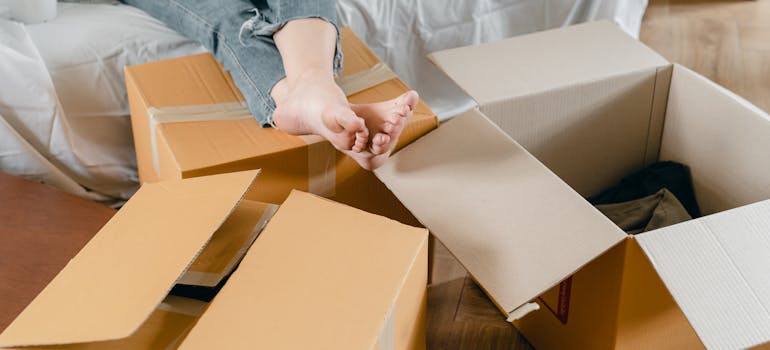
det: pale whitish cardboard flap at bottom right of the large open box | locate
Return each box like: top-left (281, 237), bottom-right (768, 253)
top-left (637, 201), bottom-right (770, 349)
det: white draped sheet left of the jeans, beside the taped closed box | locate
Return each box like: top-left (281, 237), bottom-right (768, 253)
top-left (0, 4), bottom-right (205, 203)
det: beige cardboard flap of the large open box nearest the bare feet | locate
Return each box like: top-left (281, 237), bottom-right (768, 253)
top-left (375, 110), bottom-right (626, 313)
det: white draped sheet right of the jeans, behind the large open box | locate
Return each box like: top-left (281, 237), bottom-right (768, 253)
top-left (338, 0), bottom-right (647, 120)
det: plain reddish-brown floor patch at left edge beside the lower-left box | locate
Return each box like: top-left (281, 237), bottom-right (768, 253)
top-left (0, 173), bottom-right (115, 331)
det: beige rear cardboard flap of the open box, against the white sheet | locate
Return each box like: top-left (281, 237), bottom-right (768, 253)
top-left (428, 21), bottom-right (668, 106)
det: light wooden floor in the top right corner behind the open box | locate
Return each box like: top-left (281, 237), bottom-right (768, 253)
top-left (640, 0), bottom-right (770, 111)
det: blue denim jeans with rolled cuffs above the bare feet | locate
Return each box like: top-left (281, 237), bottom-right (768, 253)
top-left (123, 0), bottom-right (342, 126)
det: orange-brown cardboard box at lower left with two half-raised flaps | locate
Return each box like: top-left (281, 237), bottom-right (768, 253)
top-left (0, 171), bottom-right (428, 349)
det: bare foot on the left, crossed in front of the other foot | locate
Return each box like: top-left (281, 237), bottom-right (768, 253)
top-left (271, 71), bottom-right (369, 154)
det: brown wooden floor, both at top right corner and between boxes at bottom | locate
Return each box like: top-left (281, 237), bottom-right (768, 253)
top-left (428, 0), bottom-right (770, 349)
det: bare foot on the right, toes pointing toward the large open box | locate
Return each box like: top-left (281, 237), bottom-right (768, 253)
top-left (349, 91), bottom-right (420, 170)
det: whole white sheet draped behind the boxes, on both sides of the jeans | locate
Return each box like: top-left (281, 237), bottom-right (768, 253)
top-left (0, 0), bottom-right (646, 203)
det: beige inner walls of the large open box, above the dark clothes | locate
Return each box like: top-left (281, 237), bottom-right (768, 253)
top-left (498, 65), bottom-right (770, 215)
